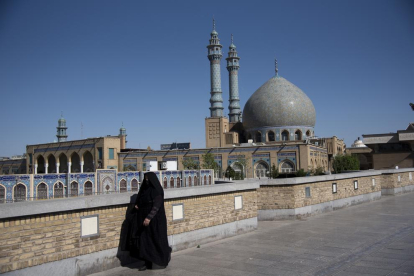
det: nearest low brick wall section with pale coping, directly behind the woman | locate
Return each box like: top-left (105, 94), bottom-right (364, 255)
top-left (0, 184), bottom-right (258, 275)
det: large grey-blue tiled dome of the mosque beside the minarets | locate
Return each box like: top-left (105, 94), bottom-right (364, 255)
top-left (243, 76), bottom-right (316, 130)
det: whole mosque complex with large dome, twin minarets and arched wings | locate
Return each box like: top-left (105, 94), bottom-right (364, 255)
top-left (0, 22), bottom-right (345, 181)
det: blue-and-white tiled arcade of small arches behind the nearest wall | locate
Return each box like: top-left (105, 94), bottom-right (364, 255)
top-left (0, 169), bottom-right (214, 202)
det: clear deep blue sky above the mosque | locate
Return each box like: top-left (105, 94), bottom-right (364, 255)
top-left (0, 0), bottom-right (414, 156)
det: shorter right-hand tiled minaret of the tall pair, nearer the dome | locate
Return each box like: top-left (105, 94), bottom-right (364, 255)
top-left (226, 35), bottom-right (241, 123)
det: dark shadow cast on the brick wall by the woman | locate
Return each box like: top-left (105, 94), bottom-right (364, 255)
top-left (116, 194), bottom-right (145, 268)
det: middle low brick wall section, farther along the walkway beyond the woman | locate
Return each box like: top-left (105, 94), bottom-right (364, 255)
top-left (258, 171), bottom-right (382, 220)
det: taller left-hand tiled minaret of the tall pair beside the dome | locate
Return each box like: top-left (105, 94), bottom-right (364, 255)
top-left (207, 19), bottom-right (223, 117)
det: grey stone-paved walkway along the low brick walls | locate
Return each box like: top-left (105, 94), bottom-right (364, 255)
top-left (93, 193), bottom-right (414, 276)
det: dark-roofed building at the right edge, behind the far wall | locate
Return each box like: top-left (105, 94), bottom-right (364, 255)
top-left (362, 123), bottom-right (414, 170)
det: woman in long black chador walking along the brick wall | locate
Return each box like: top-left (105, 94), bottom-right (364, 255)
top-left (131, 172), bottom-right (171, 270)
